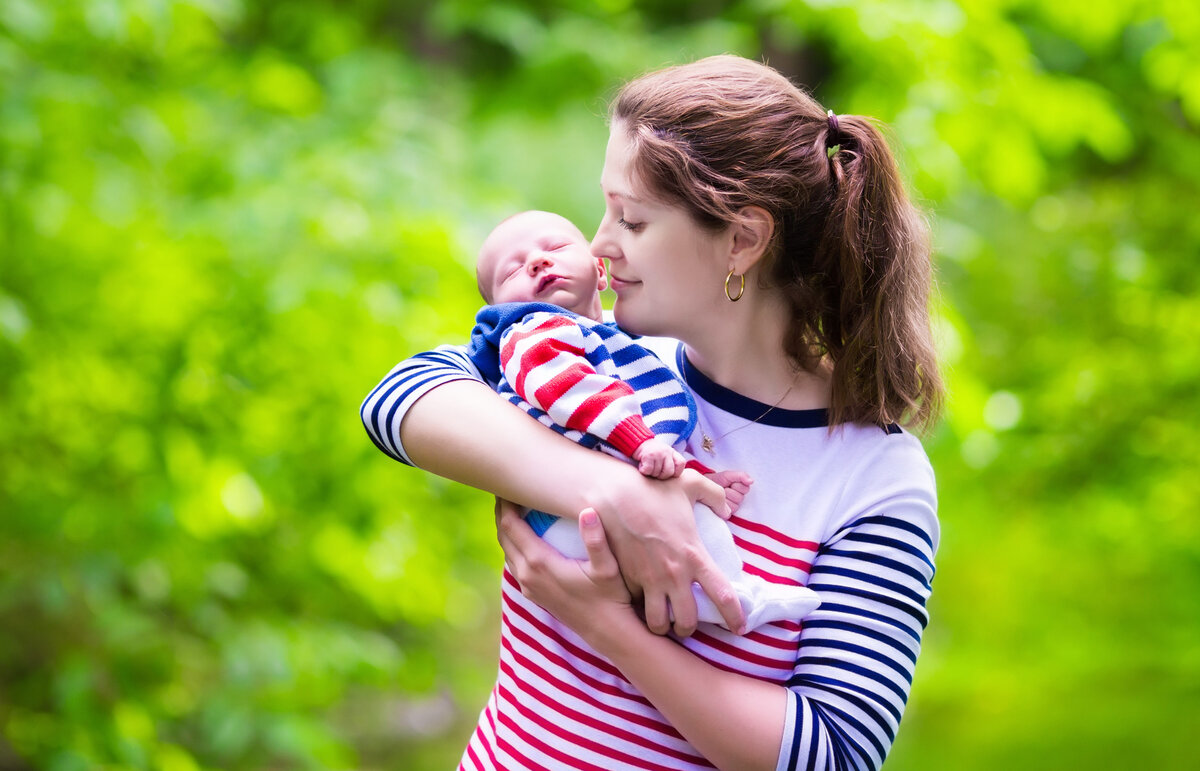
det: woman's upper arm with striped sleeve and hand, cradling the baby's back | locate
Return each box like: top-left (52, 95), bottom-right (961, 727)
top-left (361, 347), bottom-right (743, 635)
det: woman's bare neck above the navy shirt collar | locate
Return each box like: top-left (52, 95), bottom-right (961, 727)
top-left (684, 293), bottom-right (829, 410)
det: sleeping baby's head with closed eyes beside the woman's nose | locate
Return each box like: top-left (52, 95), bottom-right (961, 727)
top-left (475, 211), bottom-right (608, 321)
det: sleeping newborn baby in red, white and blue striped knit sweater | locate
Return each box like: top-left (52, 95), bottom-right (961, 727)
top-left (470, 211), bottom-right (821, 629)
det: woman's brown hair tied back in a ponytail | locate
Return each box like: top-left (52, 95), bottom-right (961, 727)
top-left (612, 55), bottom-right (943, 428)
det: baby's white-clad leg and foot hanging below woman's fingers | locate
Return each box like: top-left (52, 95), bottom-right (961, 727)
top-left (692, 503), bottom-right (821, 629)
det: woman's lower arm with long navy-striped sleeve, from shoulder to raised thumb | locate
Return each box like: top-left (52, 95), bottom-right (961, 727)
top-left (499, 437), bottom-right (937, 771)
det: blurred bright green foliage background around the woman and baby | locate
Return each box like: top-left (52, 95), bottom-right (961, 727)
top-left (0, 0), bottom-right (1200, 771)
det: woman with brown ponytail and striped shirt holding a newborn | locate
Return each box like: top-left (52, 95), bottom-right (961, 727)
top-left (362, 56), bottom-right (941, 769)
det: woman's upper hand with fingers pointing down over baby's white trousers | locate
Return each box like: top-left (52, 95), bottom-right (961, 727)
top-left (586, 467), bottom-right (745, 636)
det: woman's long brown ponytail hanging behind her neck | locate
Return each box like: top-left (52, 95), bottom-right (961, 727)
top-left (788, 114), bottom-right (943, 429)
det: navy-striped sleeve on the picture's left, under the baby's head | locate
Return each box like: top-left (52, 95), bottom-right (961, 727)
top-left (359, 346), bottom-right (486, 466)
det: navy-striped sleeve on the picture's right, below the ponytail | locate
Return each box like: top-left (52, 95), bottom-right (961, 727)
top-left (778, 436), bottom-right (938, 771)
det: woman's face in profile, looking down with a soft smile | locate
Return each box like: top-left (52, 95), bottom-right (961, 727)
top-left (592, 122), bottom-right (732, 341)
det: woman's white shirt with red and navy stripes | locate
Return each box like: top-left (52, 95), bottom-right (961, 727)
top-left (361, 331), bottom-right (938, 770)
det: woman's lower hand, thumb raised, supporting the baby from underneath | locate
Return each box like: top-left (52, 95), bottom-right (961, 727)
top-left (496, 498), bottom-right (635, 639)
